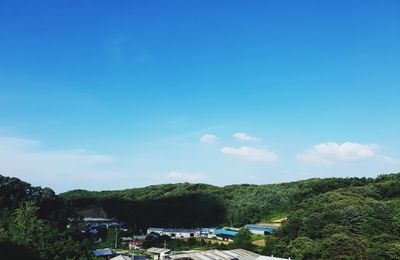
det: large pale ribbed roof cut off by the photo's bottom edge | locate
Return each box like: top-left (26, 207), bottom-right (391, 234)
top-left (167, 249), bottom-right (284, 260)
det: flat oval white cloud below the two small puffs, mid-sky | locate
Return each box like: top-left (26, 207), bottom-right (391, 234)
top-left (221, 146), bottom-right (279, 162)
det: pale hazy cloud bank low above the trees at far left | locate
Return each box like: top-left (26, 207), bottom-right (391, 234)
top-left (0, 137), bottom-right (120, 190)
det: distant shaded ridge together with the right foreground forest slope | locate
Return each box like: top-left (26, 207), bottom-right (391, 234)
top-left (61, 174), bottom-right (400, 259)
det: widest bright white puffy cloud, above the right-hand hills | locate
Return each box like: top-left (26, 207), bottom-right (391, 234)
top-left (296, 142), bottom-right (378, 164)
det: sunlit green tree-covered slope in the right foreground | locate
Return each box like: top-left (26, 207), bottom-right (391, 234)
top-left (265, 174), bottom-right (400, 259)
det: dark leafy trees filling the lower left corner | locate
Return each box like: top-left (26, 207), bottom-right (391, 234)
top-left (0, 176), bottom-right (91, 259)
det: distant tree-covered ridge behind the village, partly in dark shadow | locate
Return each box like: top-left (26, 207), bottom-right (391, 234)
top-left (61, 178), bottom-right (373, 228)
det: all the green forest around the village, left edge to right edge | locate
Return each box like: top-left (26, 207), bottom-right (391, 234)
top-left (0, 174), bottom-right (400, 259)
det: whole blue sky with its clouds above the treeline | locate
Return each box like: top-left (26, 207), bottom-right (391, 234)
top-left (0, 0), bottom-right (400, 192)
